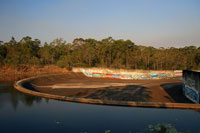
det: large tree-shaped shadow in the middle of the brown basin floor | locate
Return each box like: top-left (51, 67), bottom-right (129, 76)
top-left (75, 85), bottom-right (151, 102)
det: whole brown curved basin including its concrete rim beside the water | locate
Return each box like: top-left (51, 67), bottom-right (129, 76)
top-left (14, 72), bottom-right (200, 109)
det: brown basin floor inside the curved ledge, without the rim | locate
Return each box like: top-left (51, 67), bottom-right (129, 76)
top-left (24, 72), bottom-right (192, 103)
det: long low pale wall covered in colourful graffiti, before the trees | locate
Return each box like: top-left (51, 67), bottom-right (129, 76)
top-left (76, 68), bottom-right (182, 80)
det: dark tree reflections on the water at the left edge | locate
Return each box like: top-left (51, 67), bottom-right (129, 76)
top-left (0, 83), bottom-right (42, 110)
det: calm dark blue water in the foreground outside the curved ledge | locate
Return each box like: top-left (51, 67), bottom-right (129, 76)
top-left (0, 83), bottom-right (200, 133)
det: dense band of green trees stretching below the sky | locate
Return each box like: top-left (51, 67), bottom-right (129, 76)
top-left (0, 36), bottom-right (200, 70)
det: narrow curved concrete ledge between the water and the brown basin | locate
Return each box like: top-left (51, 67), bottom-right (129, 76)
top-left (14, 77), bottom-right (200, 109)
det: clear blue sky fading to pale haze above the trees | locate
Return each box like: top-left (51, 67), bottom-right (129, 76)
top-left (0, 0), bottom-right (200, 48)
